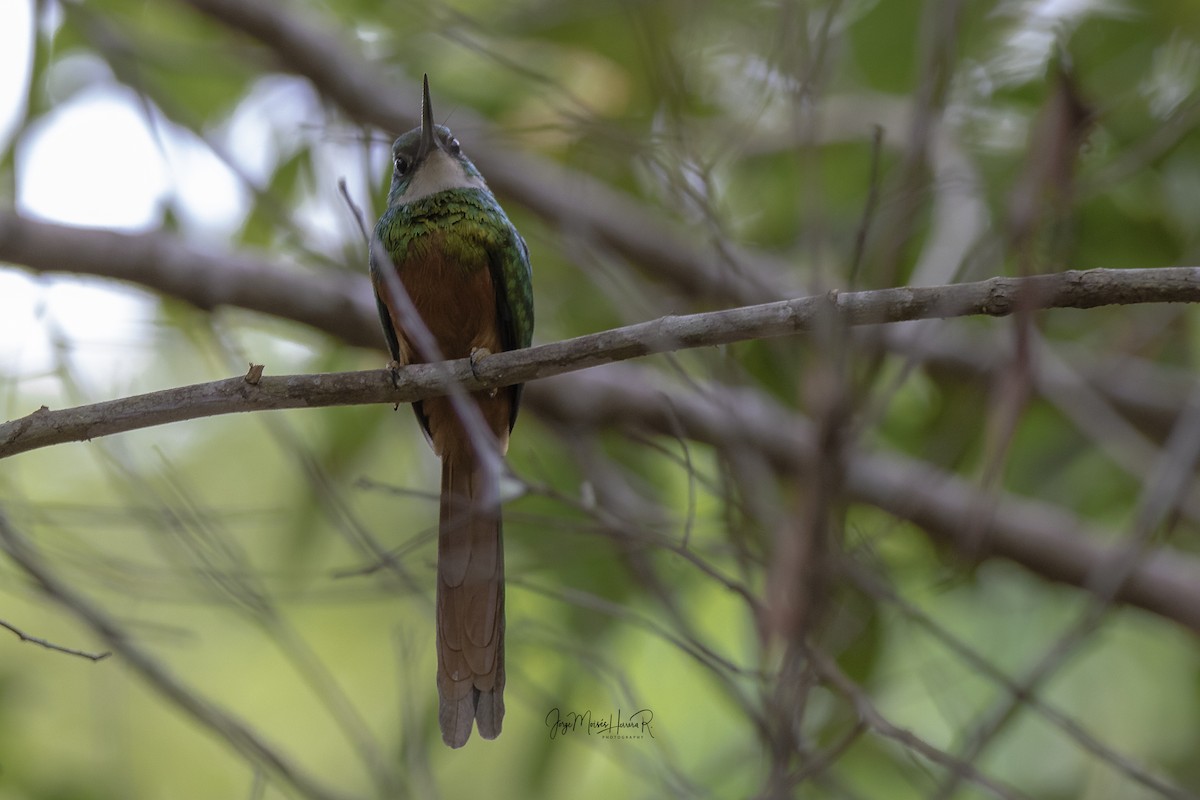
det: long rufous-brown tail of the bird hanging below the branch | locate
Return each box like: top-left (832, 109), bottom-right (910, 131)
top-left (437, 447), bottom-right (504, 747)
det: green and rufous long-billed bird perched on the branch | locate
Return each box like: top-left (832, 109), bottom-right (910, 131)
top-left (370, 74), bottom-right (533, 747)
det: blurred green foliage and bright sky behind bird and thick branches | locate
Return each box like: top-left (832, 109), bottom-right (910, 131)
top-left (0, 0), bottom-right (1200, 800)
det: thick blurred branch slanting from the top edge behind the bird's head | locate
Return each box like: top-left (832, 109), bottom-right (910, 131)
top-left (166, 0), bottom-right (797, 303)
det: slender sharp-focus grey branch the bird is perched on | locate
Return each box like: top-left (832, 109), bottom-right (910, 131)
top-left (0, 261), bottom-right (1200, 457)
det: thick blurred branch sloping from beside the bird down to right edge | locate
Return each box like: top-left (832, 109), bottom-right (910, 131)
top-left (526, 367), bottom-right (1200, 632)
